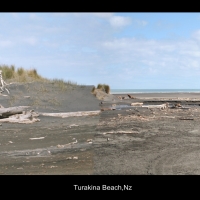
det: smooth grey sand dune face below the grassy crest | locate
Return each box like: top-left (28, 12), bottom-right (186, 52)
top-left (0, 82), bottom-right (100, 113)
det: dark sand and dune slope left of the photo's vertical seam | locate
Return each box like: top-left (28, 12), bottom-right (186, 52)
top-left (0, 83), bottom-right (100, 175)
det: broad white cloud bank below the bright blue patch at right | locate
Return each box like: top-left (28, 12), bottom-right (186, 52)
top-left (102, 32), bottom-right (200, 77)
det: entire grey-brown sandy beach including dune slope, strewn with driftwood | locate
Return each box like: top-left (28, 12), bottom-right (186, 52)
top-left (0, 82), bottom-right (200, 175)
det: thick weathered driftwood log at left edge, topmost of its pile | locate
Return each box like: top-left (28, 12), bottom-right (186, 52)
top-left (0, 106), bottom-right (30, 118)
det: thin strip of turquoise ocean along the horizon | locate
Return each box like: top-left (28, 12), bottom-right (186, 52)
top-left (110, 89), bottom-right (200, 94)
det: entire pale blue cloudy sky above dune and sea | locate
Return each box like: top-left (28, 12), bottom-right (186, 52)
top-left (0, 12), bottom-right (200, 89)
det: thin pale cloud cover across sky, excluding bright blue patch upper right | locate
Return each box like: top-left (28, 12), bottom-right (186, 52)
top-left (0, 13), bottom-right (200, 87)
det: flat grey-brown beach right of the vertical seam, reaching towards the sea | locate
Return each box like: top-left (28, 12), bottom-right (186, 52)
top-left (94, 93), bottom-right (200, 175)
